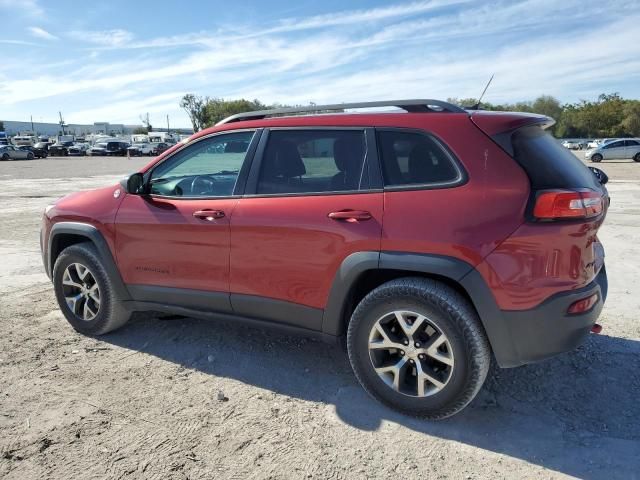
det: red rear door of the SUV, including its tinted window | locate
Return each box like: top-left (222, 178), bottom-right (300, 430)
top-left (230, 128), bottom-right (383, 330)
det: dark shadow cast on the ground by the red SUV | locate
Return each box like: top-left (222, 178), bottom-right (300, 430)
top-left (100, 314), bottom-right (640, 479)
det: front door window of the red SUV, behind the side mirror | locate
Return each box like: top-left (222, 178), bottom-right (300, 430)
top-left (150, 131), bottom-right (255, 197)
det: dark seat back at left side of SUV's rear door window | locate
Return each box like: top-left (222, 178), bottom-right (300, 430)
top-left (258, 140), bottom-right (307, 193)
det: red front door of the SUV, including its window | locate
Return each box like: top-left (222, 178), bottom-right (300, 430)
top-left (116, 131), bottom-right (255, 311)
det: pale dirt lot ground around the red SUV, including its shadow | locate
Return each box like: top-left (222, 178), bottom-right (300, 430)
top-left (0, 158), bottom-right (640, 480)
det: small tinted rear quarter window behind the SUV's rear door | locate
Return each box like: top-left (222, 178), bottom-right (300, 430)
top-left (378, 130), bottom-right (462, 186)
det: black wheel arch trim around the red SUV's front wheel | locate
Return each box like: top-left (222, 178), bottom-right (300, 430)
top-left (45, 222), bottom-right (131, 300)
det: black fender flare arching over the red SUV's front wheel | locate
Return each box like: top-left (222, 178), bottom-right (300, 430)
top-left (44, 222), bottom-right (131, 301)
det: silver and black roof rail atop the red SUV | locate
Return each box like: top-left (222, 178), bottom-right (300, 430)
top-left (216, 99), bottom-right (468, 125)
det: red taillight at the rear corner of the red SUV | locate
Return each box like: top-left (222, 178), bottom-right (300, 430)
top-left (533, 190), bottom-right (604, 220)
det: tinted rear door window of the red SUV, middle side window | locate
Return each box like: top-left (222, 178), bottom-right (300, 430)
top-left (258, 130), bottom-right (366, 194)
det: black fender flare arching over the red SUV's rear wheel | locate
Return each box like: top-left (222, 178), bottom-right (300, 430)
top-left (322, 251), bottom-right (516, 366)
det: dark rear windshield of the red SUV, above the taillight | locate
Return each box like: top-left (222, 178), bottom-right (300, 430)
top-left (511, 127), bottom-right (601, 191)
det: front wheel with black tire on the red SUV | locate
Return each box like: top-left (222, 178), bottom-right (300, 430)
top-left (53, 242), bottom-right (131, 335)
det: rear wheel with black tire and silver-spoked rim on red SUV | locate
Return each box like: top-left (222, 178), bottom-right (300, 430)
top-left (347, 277), bottom-right (491, 420)
